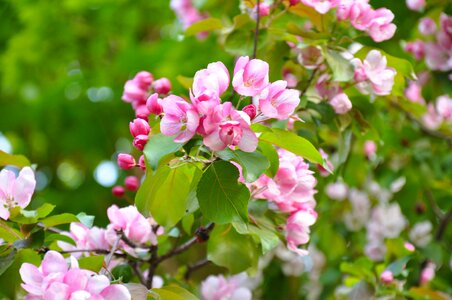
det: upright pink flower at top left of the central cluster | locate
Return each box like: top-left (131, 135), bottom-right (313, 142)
top-left (190, 62), bottom-right (229, 114)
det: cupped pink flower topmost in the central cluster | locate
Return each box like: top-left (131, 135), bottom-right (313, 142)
top-left (232, 56), bottom-right (269, 97)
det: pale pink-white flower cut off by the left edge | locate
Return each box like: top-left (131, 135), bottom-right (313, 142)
top-left (0, 167), bottom-right (36, 220)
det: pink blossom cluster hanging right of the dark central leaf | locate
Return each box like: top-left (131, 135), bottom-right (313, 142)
top-left (250, 149), bottom-right (317, 255)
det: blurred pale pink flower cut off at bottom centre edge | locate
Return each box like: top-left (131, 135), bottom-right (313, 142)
top-left (201, 273), bottom-right (252, 300)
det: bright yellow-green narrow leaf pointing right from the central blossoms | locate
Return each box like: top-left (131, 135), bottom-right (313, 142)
top-left (259, 128), bottom-right (323, 164)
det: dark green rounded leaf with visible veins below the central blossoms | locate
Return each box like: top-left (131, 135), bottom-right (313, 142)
top-left (197, 161), bottom-right (250, 224)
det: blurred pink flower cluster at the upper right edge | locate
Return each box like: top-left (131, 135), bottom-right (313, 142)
top-left (405, 13), bottom-right (452, 72)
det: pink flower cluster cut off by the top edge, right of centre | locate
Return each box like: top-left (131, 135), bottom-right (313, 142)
top-left (290, 0), bottom-right (397, 42)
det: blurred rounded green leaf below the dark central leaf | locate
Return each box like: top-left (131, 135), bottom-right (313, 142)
top-left (207, 225), bottom-right (259, 274)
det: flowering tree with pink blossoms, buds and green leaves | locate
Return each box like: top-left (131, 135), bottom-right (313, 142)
top-left (0, 0), bottom-right (452, 300)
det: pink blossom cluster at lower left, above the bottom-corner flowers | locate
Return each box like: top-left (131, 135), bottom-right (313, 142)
top-left (58, 205), bottom-right (163, 256)
